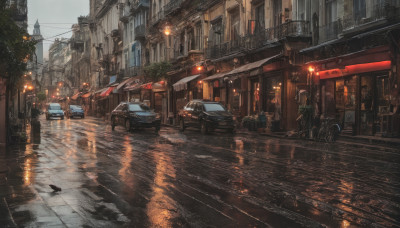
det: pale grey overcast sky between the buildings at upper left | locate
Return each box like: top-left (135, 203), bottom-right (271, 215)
top-left (28, 0), bottom-right (89, 59)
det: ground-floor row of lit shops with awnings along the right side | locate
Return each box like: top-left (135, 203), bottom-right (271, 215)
top-left (71, 43), bottom-right (400, 136)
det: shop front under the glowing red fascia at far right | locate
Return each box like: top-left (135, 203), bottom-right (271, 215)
top-left (318, 60), bottom-right (398, 136)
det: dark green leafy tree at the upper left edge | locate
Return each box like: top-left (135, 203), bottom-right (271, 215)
top-left (0, 0), bottom-right (36, 89)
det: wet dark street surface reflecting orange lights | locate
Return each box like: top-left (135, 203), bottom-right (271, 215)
top-left (0, 118), bottom-right (400, 227)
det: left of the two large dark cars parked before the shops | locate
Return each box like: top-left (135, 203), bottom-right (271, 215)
top-left (111, 102), bottom-right (161, 132)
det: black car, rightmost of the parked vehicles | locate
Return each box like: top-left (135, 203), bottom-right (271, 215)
top-left (178, 100), bottom-right (235, 134)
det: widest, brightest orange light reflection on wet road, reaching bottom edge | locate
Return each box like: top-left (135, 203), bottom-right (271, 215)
top-left (147, 144), bottom-right (178, 227)
